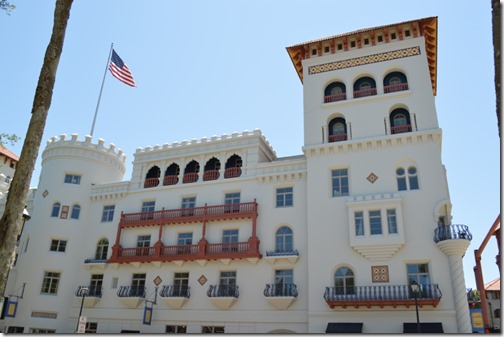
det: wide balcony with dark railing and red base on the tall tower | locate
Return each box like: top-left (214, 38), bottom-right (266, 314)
top-left (324, 284), bottom-right (442, 309)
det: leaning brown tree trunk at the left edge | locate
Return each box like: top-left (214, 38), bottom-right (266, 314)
top-left (0, 0), bottom-right (73, 296)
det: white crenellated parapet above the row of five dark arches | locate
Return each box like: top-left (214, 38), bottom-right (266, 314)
top-left (135, 129), bottom-right (276, 156)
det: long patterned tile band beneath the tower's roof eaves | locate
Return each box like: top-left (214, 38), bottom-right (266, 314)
top-left (308, 47), bottom-right (420, 75)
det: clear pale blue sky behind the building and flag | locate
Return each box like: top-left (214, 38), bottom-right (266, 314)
top-left (0, 0), bottom-right (501, 288)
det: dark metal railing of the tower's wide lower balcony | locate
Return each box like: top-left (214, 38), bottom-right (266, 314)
top-left (324, 284), bottom-right (442, 301)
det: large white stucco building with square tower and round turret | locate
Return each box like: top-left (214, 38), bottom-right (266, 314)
top-left (0, 17), bottom-right (471, 333)
